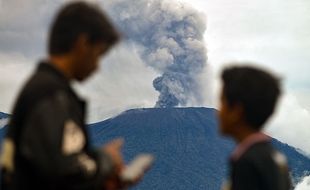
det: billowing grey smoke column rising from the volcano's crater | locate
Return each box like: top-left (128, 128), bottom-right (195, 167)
top-left (103, 0), bottom-right (207, 107)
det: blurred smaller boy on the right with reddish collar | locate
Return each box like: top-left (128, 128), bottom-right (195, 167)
top-left (219, 66), bottom-right (291, 190)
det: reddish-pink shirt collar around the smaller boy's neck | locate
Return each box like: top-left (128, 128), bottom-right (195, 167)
top-left (231, 132), bottom-right (271, 161)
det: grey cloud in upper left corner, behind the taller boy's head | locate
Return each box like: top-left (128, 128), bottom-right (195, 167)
top-left (0, 0), bottom-right (60, 58)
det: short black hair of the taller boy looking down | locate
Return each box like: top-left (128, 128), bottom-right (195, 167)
top-left (48, 2), bottom-right (119, 55)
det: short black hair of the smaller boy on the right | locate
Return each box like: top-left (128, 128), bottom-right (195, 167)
top-left (221, 66), bottom-right (281, 130)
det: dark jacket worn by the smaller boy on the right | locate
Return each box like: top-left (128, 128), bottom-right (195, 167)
top-left (231, 142), bottom-right (291, 190)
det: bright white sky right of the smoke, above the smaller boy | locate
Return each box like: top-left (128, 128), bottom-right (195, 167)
top-left (182, 0), bottom-right (310, 156)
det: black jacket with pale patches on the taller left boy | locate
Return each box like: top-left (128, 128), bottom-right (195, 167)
top-left (1, 63), bottom-right (114, 190)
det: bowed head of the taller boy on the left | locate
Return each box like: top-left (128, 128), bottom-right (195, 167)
top-left (48, 2), bottom-right (119, 80)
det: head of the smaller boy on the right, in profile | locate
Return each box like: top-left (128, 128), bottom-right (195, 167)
top-left (219, 66), bottom-right (281, 135)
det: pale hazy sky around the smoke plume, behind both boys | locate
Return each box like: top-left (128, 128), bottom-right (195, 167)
top-left (0, 0), bottom-right (310, 154)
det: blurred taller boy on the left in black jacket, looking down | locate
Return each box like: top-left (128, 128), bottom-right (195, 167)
top-left (1, 2), bottom-right (137, 190)
